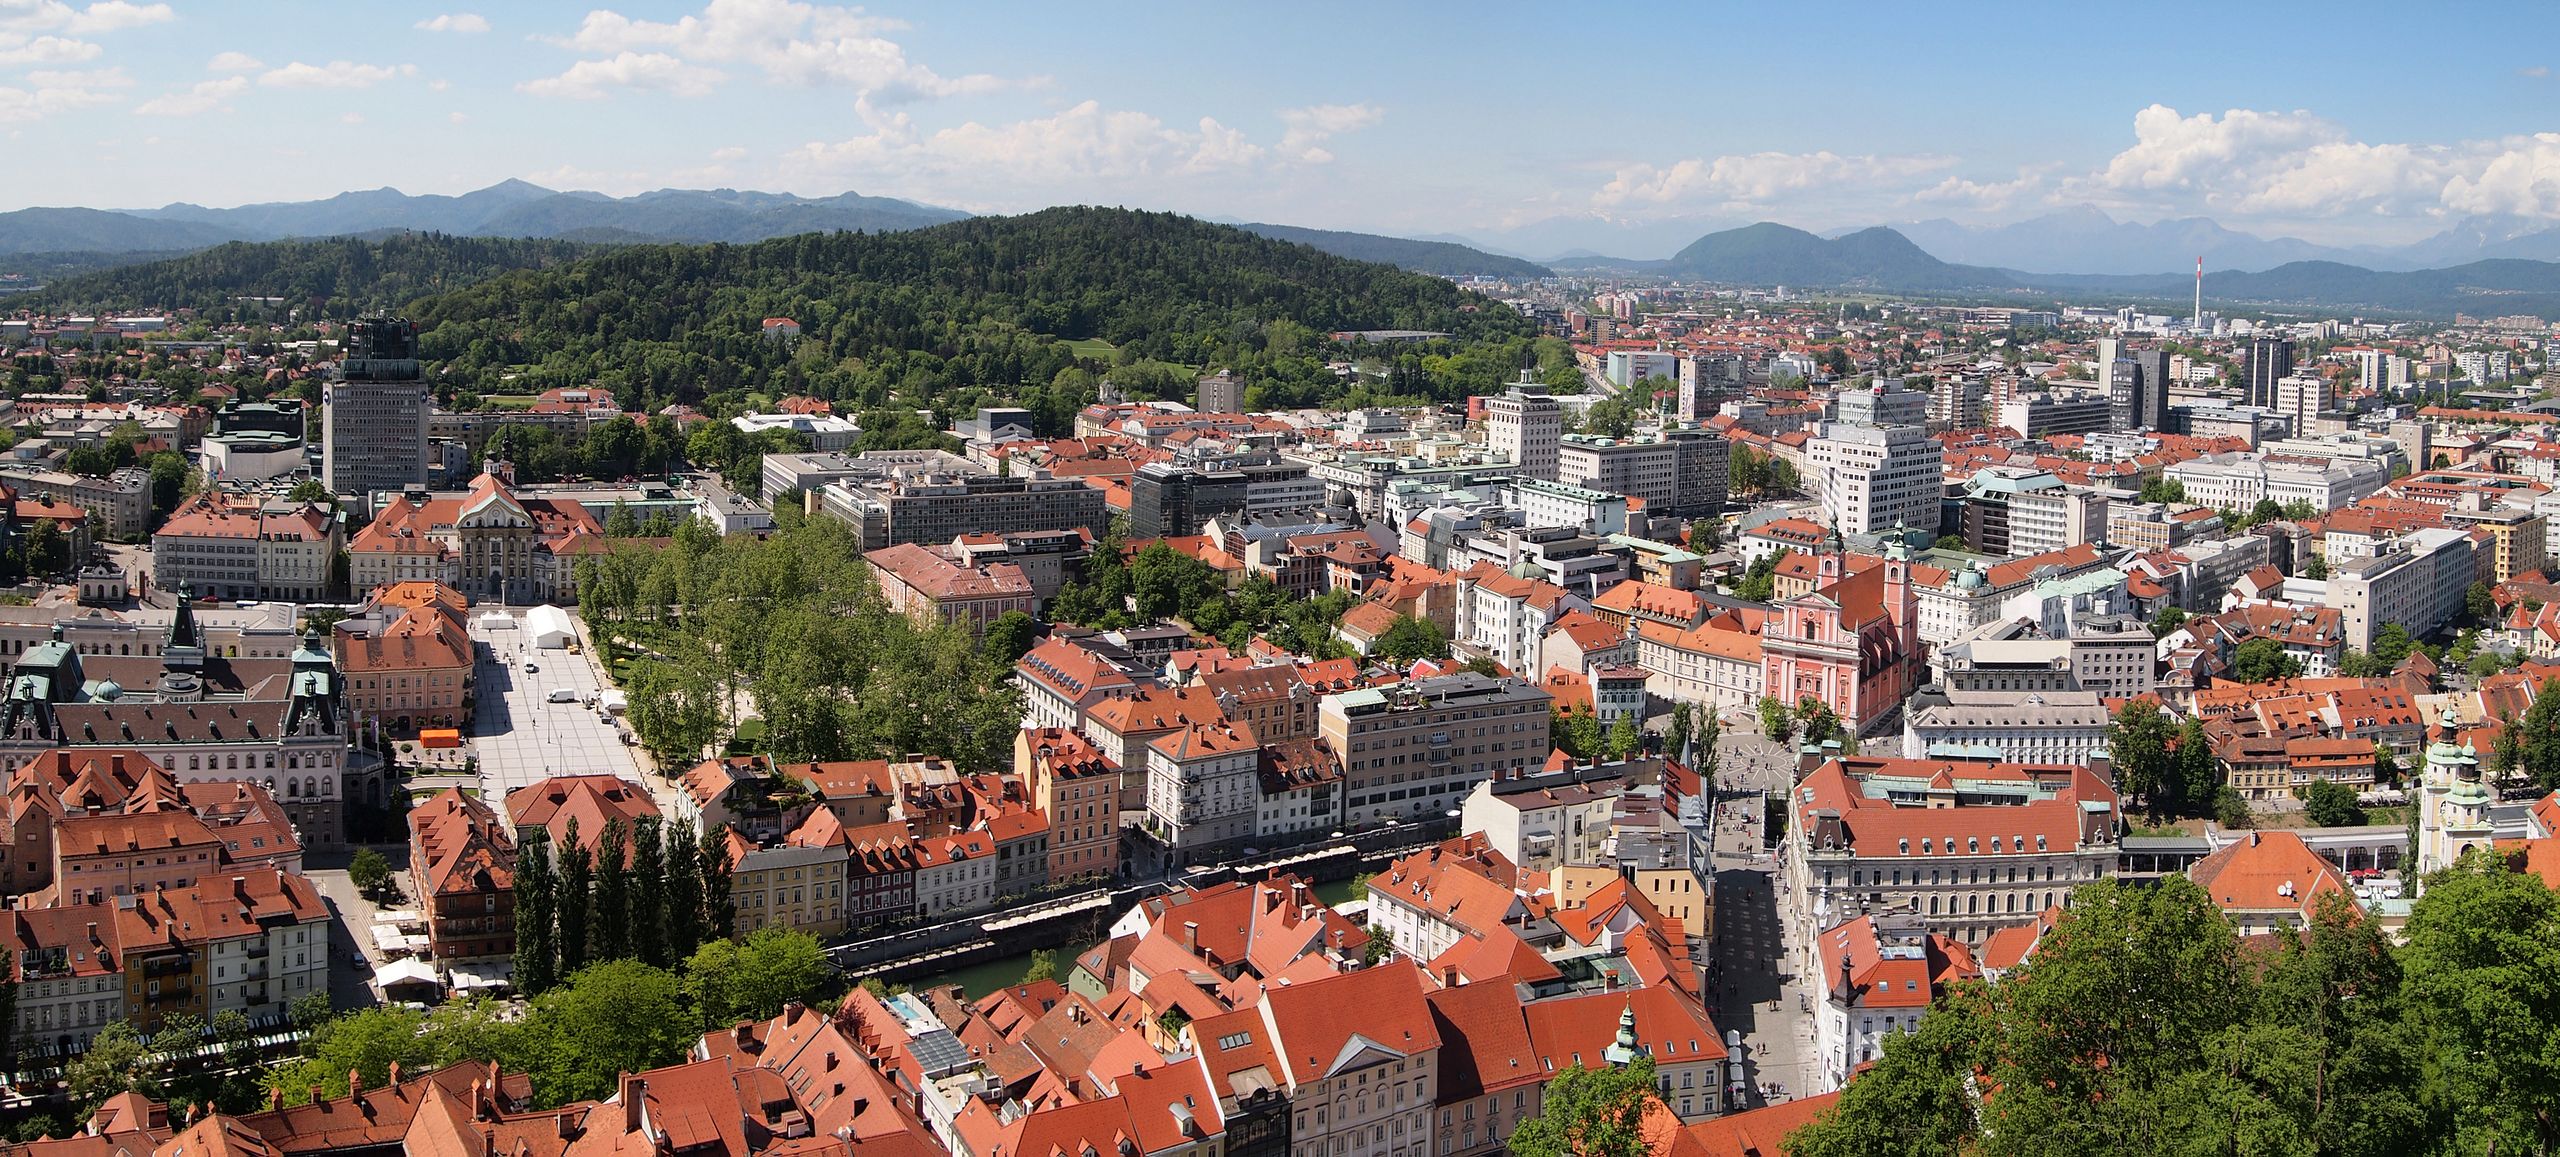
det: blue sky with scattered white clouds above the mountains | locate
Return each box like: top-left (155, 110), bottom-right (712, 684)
top-left (0, 0), bottom-right (2560, 246)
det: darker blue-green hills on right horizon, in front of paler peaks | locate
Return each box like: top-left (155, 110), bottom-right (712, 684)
top-left (1633, 223), bottom-right (2560, 317)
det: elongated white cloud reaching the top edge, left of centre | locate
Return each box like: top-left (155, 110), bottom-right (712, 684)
top-left (556, 0), bottom-right (1004, 102)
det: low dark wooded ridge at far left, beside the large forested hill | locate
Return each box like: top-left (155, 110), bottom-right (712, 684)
top-left (30, 233), bottom-right (596, 320)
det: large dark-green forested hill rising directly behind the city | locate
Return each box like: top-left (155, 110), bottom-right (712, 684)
top-left (410, 207), bottom-right (1531, 410)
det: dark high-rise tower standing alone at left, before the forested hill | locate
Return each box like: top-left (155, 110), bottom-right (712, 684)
top-left (320, 317), bottom-right (428, 494)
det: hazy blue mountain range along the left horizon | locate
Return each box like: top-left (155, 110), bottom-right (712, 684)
top-left (0, 182), bottom-right (968, 253)
